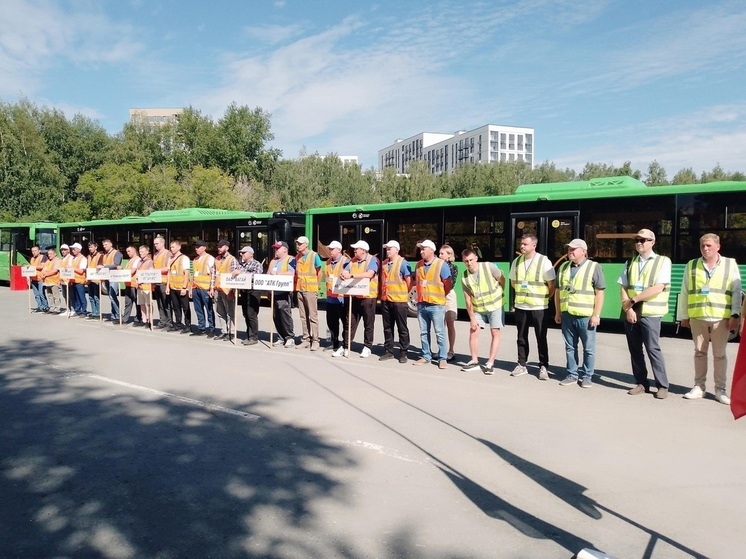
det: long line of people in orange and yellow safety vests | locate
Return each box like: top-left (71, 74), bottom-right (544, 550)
top-left (30, 229), bottom-right (744, 404)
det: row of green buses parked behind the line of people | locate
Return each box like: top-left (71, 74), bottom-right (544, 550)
top-left (0, 177), bottom-right (746, 322)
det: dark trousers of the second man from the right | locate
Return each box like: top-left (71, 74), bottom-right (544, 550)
top-left (624, 316), bottom-right (668, 389)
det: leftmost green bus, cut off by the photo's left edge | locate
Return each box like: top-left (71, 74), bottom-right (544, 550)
top-left (0, 221), bottom-right (60, 285)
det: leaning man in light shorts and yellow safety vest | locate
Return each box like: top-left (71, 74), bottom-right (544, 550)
top-left (461, 248), bottom-right (505, 375)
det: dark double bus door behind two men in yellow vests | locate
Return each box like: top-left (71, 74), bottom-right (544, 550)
top-left (511, 211), bottom-right (580, 267)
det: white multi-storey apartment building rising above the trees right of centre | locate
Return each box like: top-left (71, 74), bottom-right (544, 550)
top-left (378, 124), bottom-right (536, 175)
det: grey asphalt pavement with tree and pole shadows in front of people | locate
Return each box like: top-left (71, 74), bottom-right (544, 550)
top-left (0, 288), bottom-right (746, 559)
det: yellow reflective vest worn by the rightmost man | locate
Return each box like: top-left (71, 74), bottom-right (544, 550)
top-left (684, 256), bottom-right (736, 319)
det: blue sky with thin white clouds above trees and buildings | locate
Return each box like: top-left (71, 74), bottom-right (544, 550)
top-left (0, 0), bottom-right (746, 178)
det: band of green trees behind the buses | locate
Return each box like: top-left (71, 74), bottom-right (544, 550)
top-left (0, 99), bottom-right (746, 221)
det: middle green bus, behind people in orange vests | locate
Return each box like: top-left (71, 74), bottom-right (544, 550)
top-left (59, 208), bottom-right (305, 265)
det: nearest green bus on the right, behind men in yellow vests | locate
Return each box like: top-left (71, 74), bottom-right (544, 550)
top-left (306, 177), bottom-right (746, 322)
